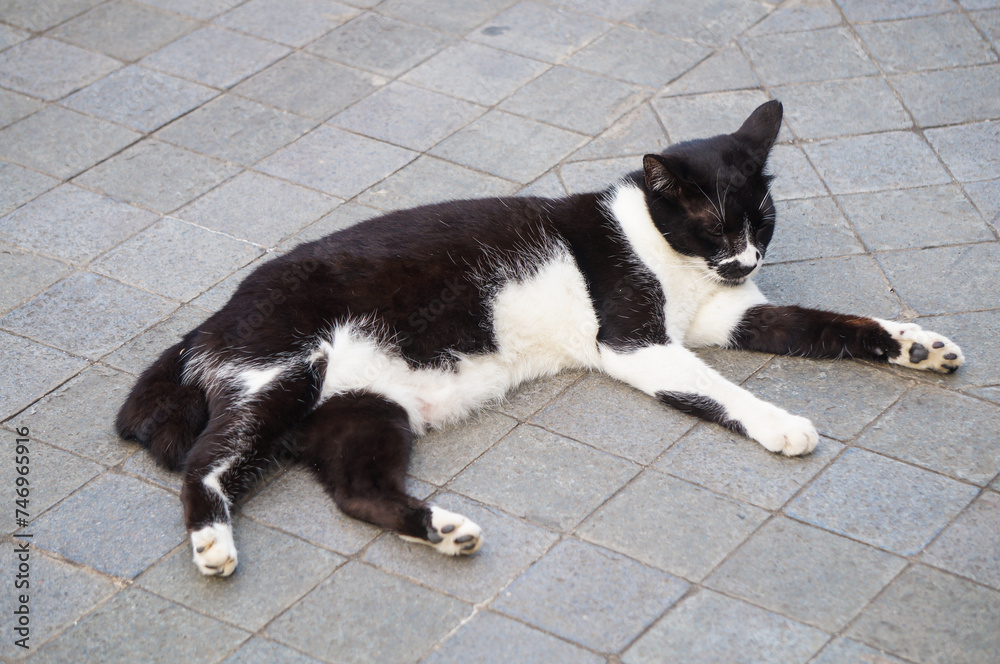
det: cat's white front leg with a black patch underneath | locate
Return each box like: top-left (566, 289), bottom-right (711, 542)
top-left (601, 343), bottom-right (819, 456)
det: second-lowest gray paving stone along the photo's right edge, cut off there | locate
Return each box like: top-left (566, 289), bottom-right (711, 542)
top-left (920, 491), bottom-right (1000, 589)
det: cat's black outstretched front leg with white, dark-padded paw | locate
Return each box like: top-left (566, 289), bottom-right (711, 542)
top-left (723, 304), bottom-right (965, 373)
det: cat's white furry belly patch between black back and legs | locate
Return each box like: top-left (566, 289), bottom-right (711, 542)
top-left (313, 253), bottom-right (600, 431)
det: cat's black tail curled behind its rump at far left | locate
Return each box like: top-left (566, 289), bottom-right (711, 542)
top-left (115, 332), bottom-right (208, 470)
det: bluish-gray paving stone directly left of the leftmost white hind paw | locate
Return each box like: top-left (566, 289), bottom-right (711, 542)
top-left (32, 474), bottom-right (186, 579)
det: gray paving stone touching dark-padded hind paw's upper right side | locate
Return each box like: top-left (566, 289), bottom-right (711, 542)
top-left (450, 425), bottom-right (639, 530)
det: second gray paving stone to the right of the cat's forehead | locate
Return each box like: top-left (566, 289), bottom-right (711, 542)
top-left (805, 132), bottom-right (951, 194)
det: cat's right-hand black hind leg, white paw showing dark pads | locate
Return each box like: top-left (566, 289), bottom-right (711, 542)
top-left (300, 392), bottom-right (483, 556)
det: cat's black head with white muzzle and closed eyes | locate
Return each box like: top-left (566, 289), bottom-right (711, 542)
top-left (643, 101), bottom-right (782, 285)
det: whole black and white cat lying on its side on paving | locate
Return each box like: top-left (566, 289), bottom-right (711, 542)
top-left (117, 101), bottom-right (963, 576)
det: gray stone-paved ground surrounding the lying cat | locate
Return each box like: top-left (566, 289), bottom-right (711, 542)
top-left (0, 0), bottom-right (1000, 664)
